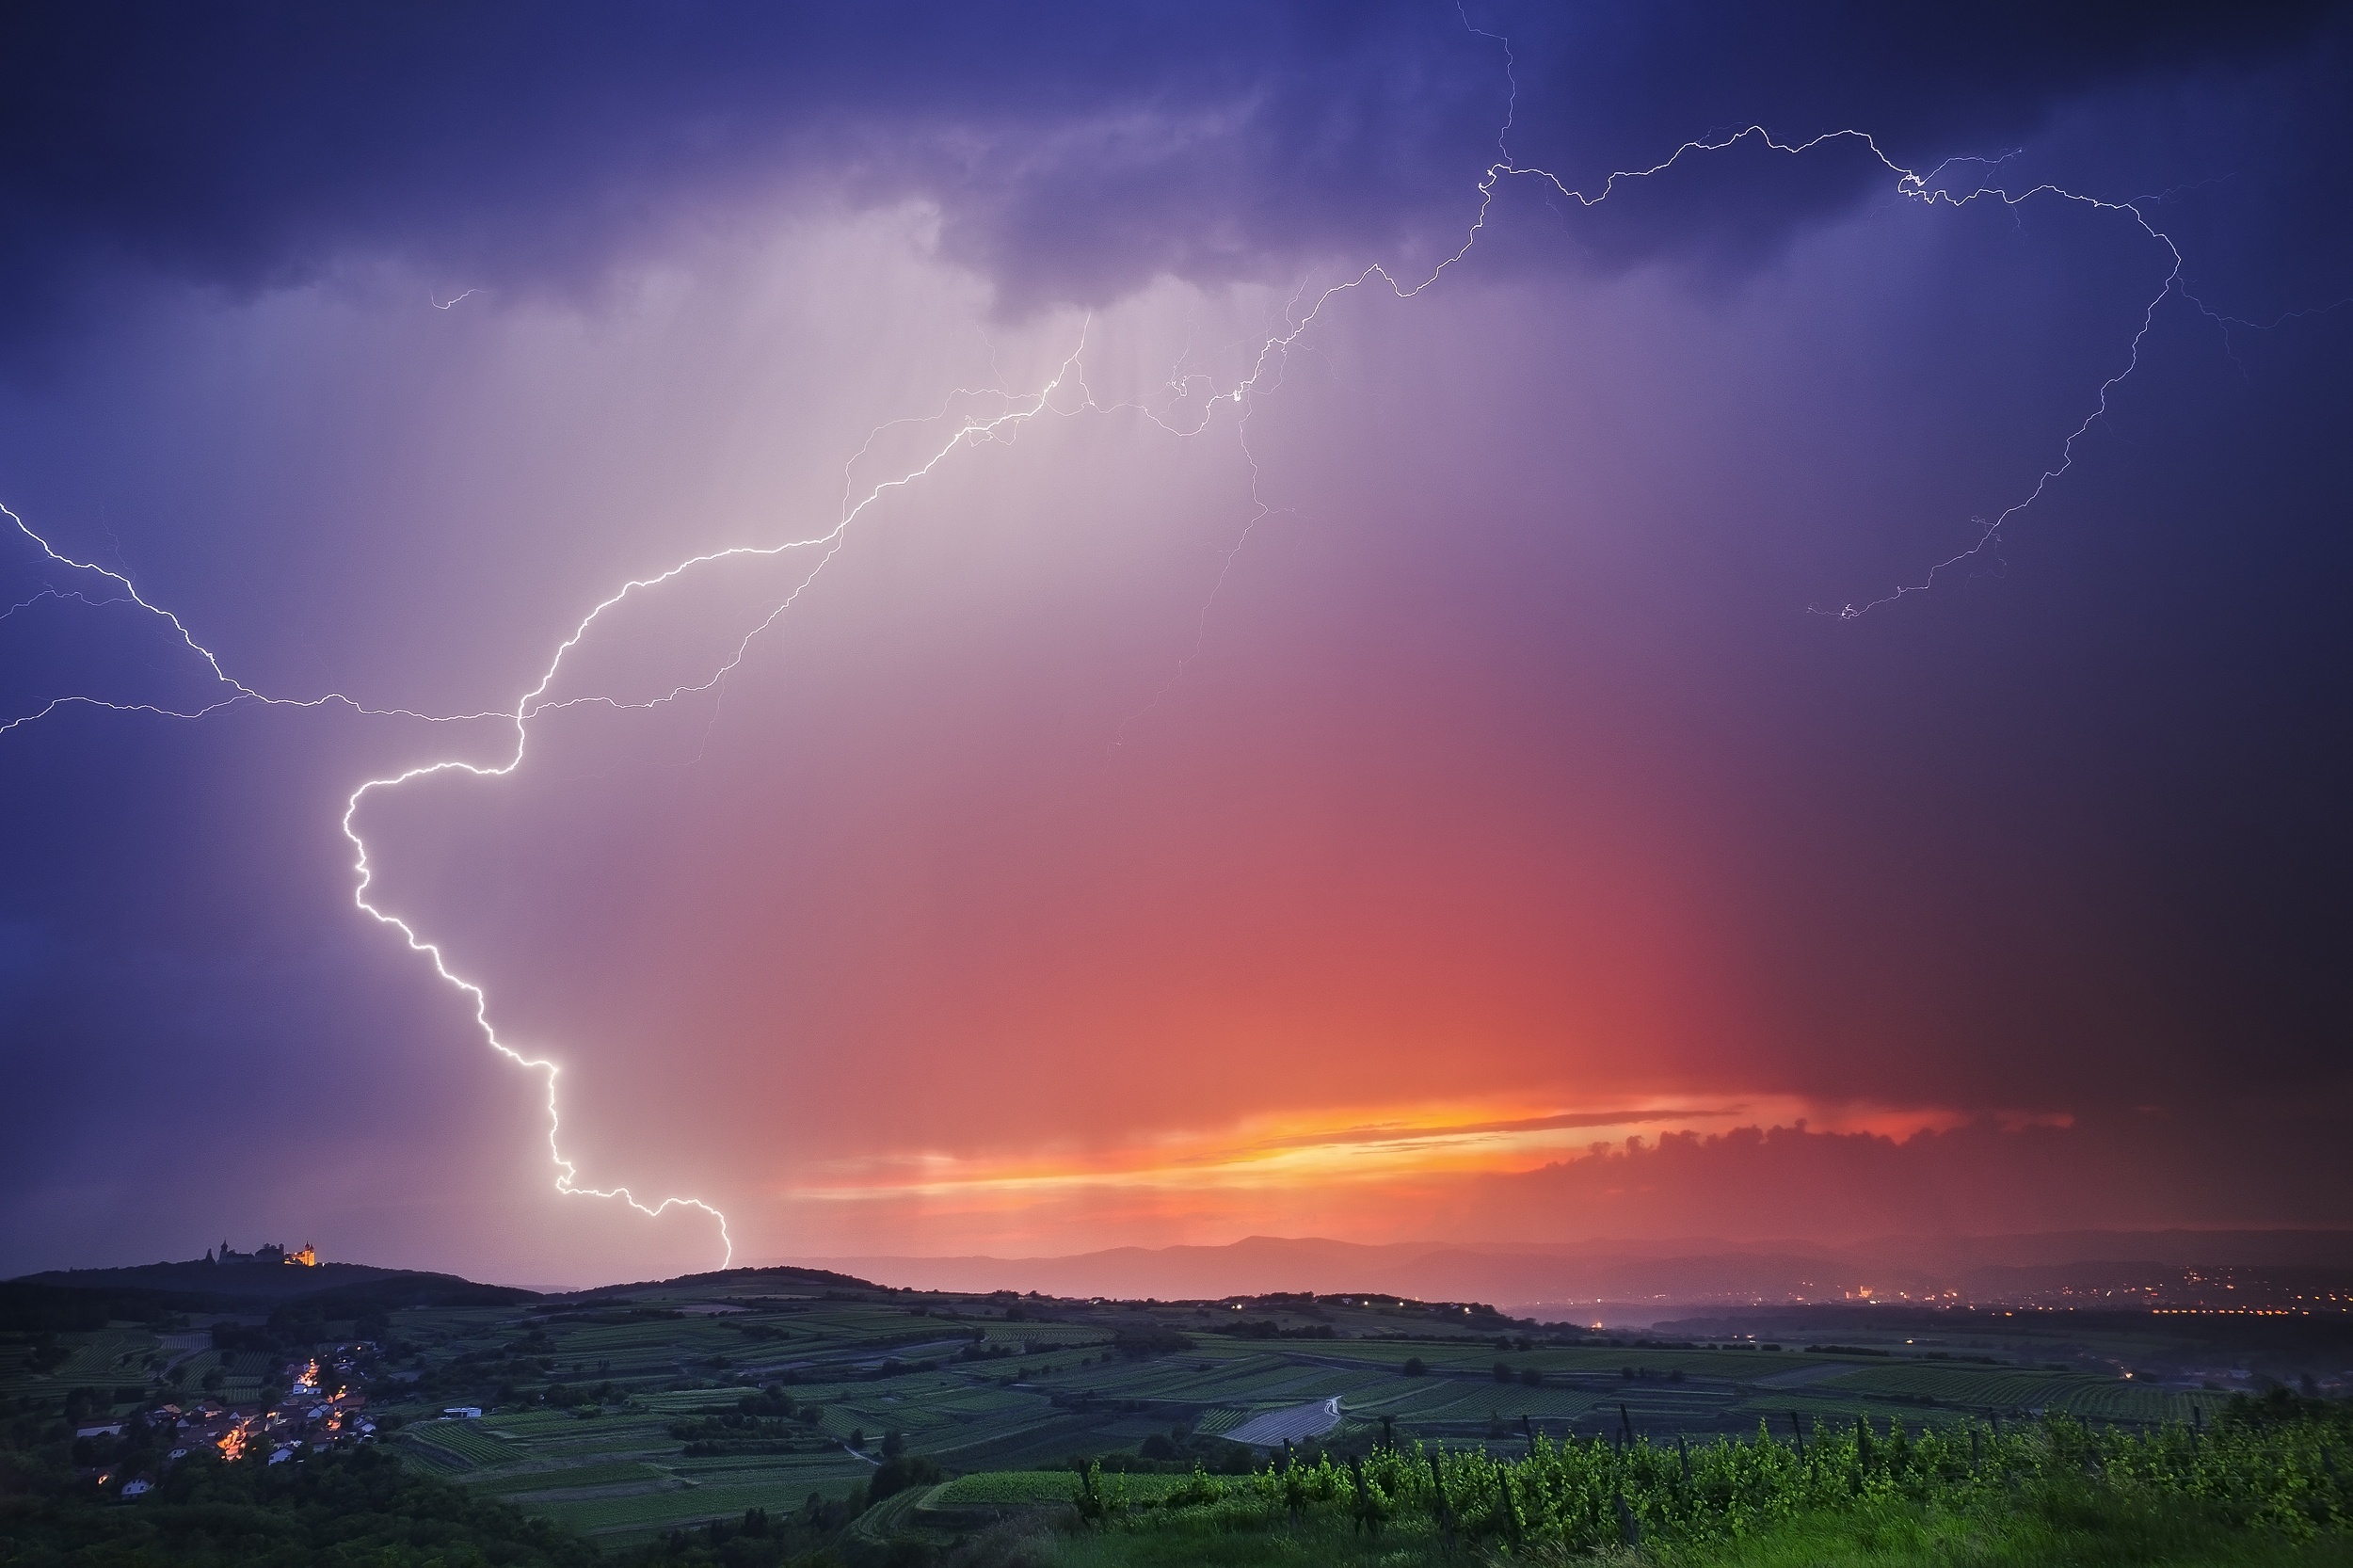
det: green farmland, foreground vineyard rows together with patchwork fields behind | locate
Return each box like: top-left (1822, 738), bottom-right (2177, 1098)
top-left (0, 1272), bottom-right (2353, 1568)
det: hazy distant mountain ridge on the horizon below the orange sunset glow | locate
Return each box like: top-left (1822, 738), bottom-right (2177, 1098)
top-left (772, 1229), bottom-right (2353, 1311)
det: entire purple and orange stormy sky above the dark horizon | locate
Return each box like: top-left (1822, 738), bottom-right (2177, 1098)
top-left (0, 3), bottom-right (2353, 1283)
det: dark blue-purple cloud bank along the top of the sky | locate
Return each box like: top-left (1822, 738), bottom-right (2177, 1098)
top-left (0, 0), bottom-right (2344, 342)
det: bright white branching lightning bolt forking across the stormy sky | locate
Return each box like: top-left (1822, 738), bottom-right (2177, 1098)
top-left (0, 17), bottom-right (2334, 1267)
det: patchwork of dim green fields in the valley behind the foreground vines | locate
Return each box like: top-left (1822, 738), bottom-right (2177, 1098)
top-left (0, 1272), bottom-right (2353, 1546)
